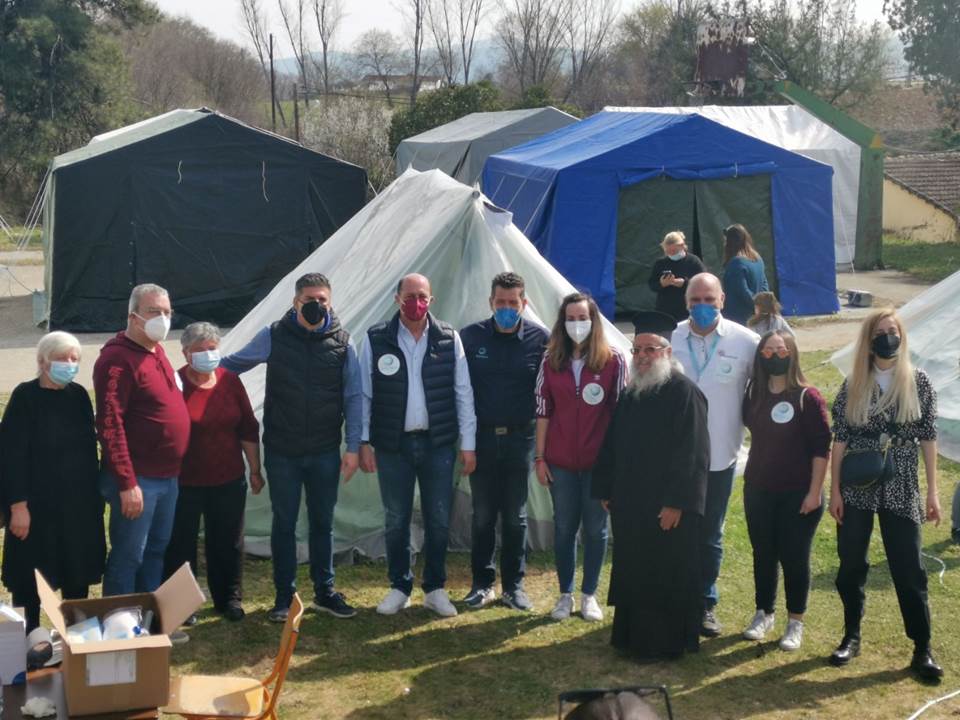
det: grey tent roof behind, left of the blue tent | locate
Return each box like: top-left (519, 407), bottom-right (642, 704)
top-left (397, 107), bottom-right (577, 185)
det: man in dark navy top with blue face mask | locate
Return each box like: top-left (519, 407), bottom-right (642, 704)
top-left (460, 272), bottom-right (548, 610)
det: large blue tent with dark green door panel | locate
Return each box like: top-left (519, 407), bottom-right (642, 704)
top-left (483, 112), bottom-right (839, 316)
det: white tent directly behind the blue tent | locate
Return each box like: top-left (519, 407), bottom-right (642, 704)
top-left (604, 105), bottom-right (860, 266)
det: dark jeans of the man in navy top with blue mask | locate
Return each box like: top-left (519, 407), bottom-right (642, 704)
top-left (470, 425), bottom-right (533, 592)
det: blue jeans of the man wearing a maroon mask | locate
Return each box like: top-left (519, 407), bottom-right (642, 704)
top-left (376, 433), bottom-right (456, 595)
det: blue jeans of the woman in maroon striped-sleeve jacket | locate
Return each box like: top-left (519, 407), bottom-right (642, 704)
top-left (550, 465), bottom-right (607, 595)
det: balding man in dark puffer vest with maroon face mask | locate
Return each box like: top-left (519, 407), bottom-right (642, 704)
top-left (360, 274), bottom-right (477, 617)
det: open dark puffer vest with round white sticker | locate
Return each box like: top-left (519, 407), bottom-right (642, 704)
top-left (367, 313), bottom-right (460, 452)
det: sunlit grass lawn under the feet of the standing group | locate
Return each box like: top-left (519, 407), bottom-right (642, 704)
top-left (1, 352), bottom-right (960, 720)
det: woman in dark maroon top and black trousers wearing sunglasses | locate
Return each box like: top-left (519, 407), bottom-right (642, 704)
top-left (743, 330), bottom-right (831, 650)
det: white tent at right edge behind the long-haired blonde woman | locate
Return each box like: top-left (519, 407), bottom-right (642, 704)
top-left (830, 272), bottom-right (960, 462)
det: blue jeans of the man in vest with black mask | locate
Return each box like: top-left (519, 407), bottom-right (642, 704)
top-left (263, 447), bottom-right (340, 608)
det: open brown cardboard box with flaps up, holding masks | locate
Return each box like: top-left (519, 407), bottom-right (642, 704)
top-left (36, 563), bottom-right (205, 717)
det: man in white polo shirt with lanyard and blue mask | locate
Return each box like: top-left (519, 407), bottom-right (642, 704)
top-left (673, 273), bottom-right (760, 637)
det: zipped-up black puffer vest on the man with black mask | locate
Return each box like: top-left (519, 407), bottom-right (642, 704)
top-left (263, 312), bottom-right (350, 457)
